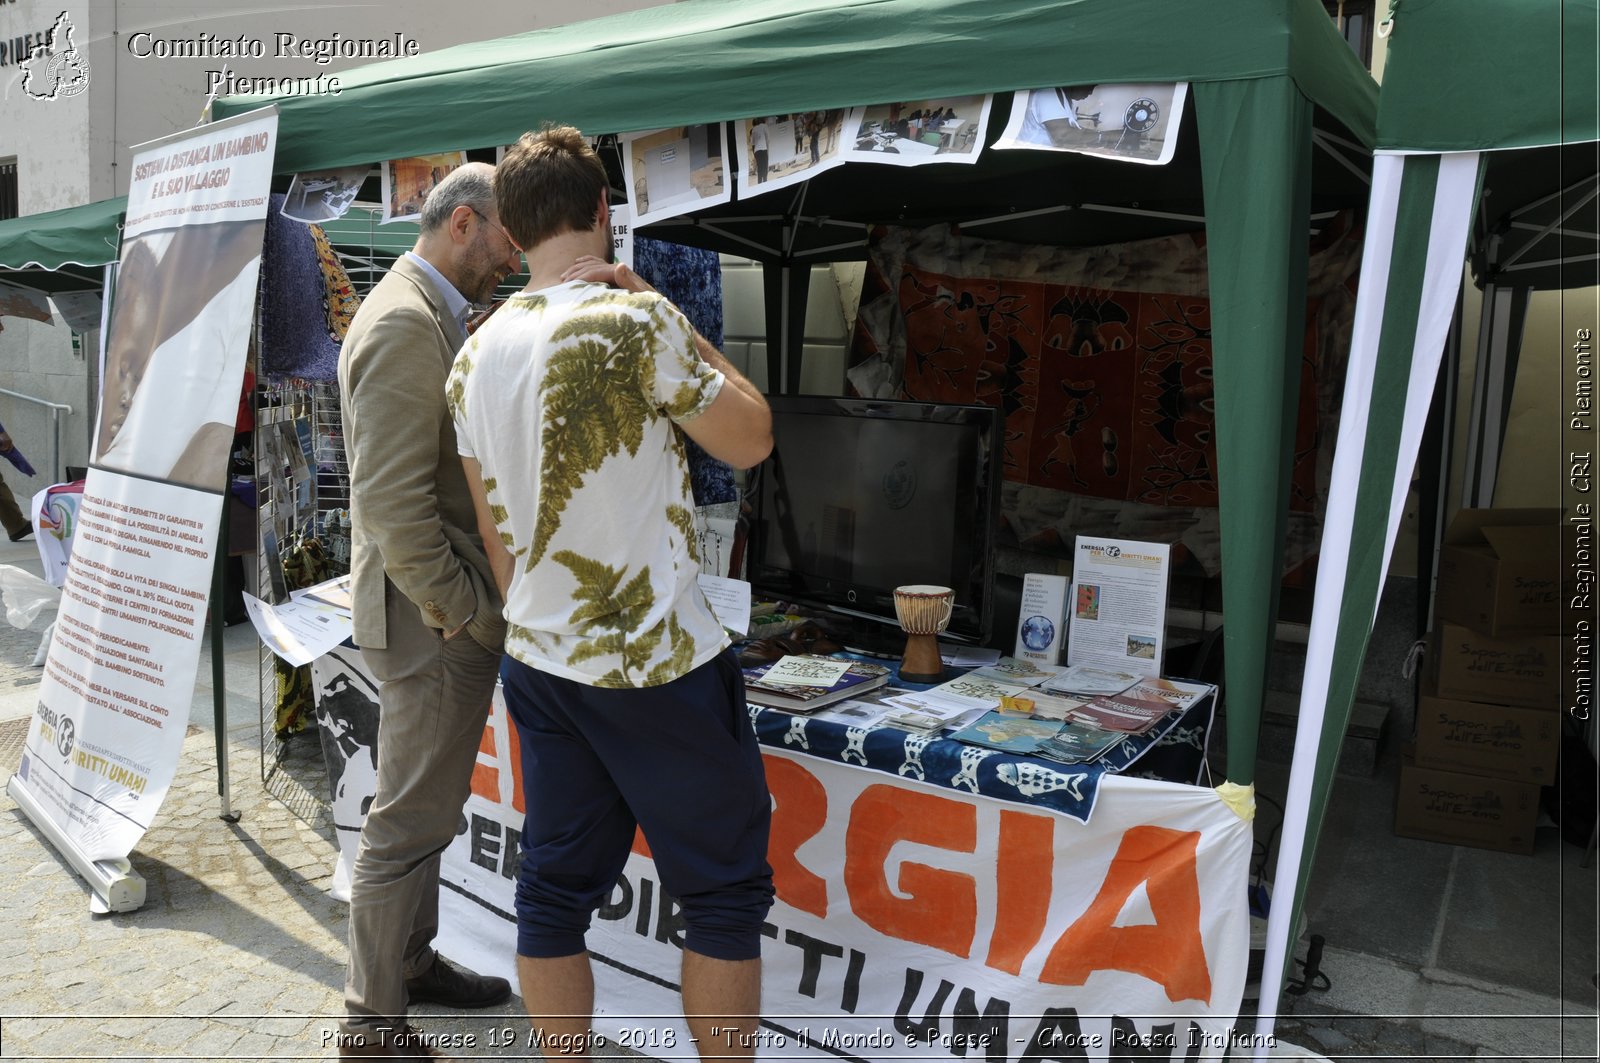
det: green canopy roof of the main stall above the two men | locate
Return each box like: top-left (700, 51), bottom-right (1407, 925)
top-left (213, 0), bottom-right (1376, 171)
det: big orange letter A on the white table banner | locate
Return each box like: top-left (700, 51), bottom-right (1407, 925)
top-left (1038, 826), bottom-right (1211, 1004)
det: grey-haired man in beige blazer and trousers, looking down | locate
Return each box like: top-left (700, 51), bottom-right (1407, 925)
top-left (338, 163), bottom-right (522, 1058)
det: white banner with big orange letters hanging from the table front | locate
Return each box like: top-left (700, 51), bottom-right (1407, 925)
top-left (437, 685), bottom-right (1251, 1063)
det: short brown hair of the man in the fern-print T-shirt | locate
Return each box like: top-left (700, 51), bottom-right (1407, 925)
top-left (494, 125), bottom-right (611, 248)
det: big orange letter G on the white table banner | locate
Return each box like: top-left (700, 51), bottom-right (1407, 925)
top-left (845, 784), bottom-right (978, 959)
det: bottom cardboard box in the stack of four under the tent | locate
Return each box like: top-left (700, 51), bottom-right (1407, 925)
top-left (1395, 757), bottom-right (1539, 853)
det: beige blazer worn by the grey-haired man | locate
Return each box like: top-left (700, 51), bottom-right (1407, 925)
top-left (339, 258), bottom-right (506, 653)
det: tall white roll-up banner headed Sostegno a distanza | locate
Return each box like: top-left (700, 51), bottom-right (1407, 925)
top-left (11, 109), bottom-right (277, 861)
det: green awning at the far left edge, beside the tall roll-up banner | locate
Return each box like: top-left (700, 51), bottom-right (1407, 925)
top-left (0, 197), bottom-right (128, 291)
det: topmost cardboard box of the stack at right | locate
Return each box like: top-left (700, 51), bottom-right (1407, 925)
top-left (1435, 509), bottom-right (1562, 637)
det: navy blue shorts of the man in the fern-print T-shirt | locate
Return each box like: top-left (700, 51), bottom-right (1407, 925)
top-left (501, 652), bottom-right (773, 961)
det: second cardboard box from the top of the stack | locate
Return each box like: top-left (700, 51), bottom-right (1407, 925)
top-left (1429, 623), bottom-right (1562, 709)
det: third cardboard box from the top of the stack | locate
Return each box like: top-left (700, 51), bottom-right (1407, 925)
top-left (1416, 690), bottom-right (1562, 786)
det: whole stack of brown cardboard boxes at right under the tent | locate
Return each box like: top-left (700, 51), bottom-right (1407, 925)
top-left (1395, 509), bottom-right (1562, 853)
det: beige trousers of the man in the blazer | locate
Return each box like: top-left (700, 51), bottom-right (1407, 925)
top-left (344, 580), bottom-right (501, 1033)
